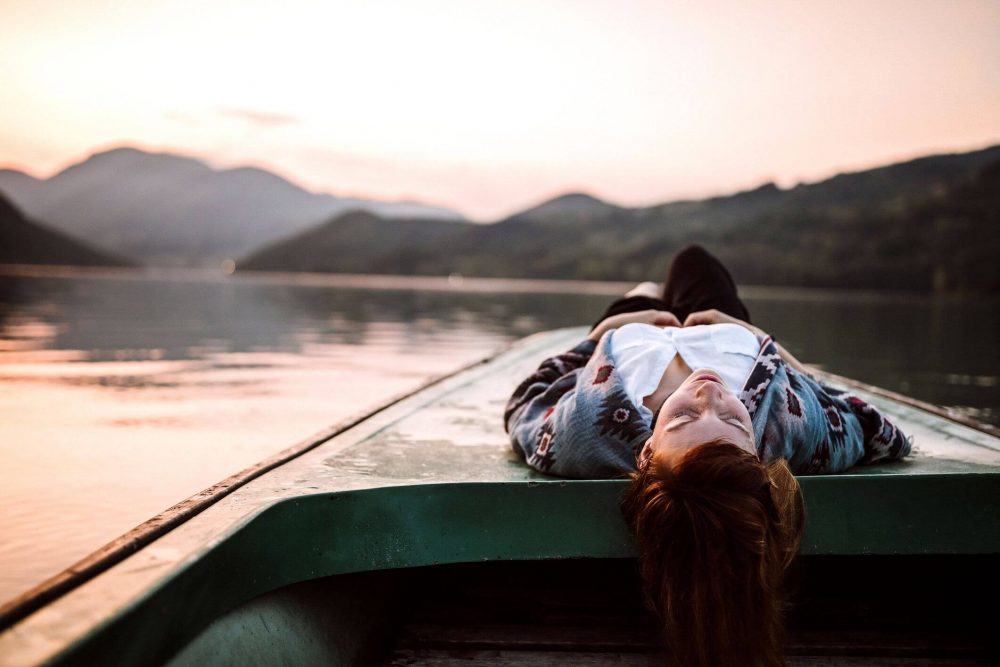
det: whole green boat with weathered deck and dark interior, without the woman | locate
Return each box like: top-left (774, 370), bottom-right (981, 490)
top-left (0, 329), bottom-right (1000, 666)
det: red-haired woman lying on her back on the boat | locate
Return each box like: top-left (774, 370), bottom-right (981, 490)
top-left (504, 246), bottom-right (910, 667)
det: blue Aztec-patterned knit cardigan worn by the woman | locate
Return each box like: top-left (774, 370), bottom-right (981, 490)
top-left (504, 331), bottom-right (911, 479)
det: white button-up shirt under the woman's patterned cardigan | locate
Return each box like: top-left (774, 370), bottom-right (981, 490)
top-left (611, 324), bottom-right (760, 422)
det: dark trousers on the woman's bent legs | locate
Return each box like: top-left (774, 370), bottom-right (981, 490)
top-left (594, 245), bottom-right (750, 327)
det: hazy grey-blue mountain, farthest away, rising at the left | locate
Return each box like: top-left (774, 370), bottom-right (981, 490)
top-left (0, 148), bottom-right (461, 265)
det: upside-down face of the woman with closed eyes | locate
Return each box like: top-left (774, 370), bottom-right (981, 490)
top-left (639, 368), bottom-right (757, 464)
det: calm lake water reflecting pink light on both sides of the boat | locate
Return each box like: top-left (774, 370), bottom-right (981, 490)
top-left (0, 274), bottom-right (1000, 599)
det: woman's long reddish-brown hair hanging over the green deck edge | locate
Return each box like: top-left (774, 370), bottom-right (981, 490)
top-left (622, 441), bottom-right (805, 667)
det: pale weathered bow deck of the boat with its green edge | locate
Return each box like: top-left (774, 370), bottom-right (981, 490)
top-left (0, 329), bottom-right (1000, 665)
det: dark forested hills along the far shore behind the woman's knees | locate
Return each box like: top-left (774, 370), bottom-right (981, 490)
top-left (239, 146), bottom-right (1000, 293)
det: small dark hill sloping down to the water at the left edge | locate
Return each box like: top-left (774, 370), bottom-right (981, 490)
top-left (0, 194), bottom-right (129, 266)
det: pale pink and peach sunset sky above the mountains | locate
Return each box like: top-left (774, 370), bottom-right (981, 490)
top-left (0, 0), bottom-right (1000, 220)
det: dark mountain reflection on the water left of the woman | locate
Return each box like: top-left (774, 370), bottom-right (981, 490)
top-left (0, 278), bottom-right (606, 361)
